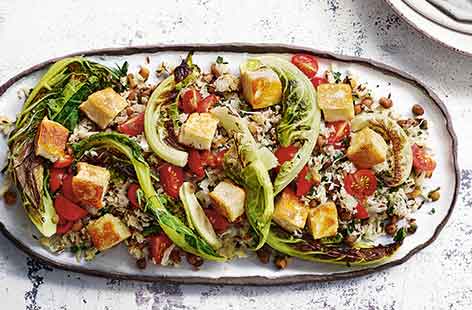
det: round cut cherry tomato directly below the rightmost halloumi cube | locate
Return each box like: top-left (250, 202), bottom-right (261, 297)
top-left (344, 169), bottom-right (377, 199)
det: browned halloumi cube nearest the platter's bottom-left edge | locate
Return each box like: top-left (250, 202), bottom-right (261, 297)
top-left (87, 213), bottom-right (131, 251)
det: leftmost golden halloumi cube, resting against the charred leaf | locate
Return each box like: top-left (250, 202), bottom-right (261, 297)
top-left (35, 117), bottom-right (69, 162)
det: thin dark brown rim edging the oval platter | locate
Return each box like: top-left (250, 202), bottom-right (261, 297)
top-left (0, 43), bottom-right (460, 285)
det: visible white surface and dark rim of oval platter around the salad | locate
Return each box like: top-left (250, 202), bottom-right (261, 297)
top-left (0, 44), bottom-right (459, 285)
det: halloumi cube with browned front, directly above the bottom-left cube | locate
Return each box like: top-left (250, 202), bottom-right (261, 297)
top-left (72, 162), bottom-right (110, 209)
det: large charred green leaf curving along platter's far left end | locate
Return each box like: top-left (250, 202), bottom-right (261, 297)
top-left (7, 57), bottom-right (126, 236)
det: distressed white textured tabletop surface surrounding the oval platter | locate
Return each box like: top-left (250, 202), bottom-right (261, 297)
top-left (0, 0), bottom-right (472, 310)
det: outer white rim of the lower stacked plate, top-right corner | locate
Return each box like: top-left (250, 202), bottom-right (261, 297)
top-left (385, 0), bottom-right (472, 55)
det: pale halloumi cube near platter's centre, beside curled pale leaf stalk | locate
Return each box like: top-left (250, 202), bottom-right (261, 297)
top-left (178, 113), bottom-right (218, 150)
